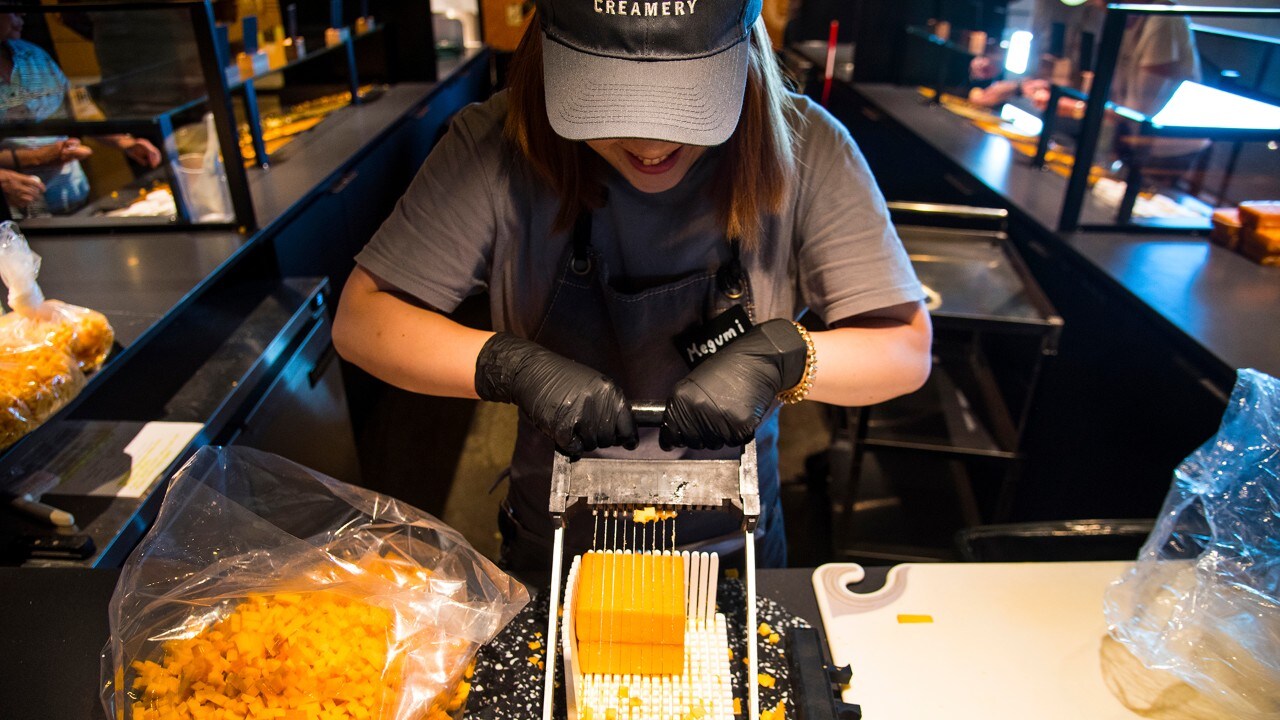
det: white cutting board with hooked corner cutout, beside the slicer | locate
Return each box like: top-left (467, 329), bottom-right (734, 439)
top-left (813, 562), bottom-right (1139, 720)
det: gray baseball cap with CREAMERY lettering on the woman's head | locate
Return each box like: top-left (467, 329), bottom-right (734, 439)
top-left (536, 0), bottom-right (762, 145)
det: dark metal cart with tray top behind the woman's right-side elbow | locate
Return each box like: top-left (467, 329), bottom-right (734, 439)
top-left (836, 210), bottom-right (1062, 557)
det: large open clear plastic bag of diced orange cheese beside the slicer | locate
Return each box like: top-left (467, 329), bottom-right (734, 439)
top-left (102, 447), bottom-right (529, 720)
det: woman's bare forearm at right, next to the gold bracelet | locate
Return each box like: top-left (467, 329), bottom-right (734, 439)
top-left (809, 310), bottom-right (933, 406)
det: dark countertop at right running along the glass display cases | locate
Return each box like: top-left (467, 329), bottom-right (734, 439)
top-left (850, 85), bottom-right (1280, 386)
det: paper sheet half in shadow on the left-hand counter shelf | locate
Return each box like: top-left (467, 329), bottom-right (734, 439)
top-left (5, 420), bottom-right (204, 497)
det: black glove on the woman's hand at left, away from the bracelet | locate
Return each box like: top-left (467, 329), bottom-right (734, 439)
top-left (476, 333), bottom-right (637, 455)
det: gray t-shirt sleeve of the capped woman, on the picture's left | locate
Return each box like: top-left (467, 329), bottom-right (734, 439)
top-left (356, 99), bottom-right (502, 313)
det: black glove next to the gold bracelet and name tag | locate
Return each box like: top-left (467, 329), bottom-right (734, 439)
top-left (658, 320), bottom-right (808, 450)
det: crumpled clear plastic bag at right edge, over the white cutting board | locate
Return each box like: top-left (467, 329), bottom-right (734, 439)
top-left (1105, 370), bottom-right (1280, 720)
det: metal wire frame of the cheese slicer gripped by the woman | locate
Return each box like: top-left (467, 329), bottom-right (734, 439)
top-left (543, 404), bottom-right (760, 720)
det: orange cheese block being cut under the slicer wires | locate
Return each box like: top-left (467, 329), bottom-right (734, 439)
top-left (573, 552), bottom-right (685, 675)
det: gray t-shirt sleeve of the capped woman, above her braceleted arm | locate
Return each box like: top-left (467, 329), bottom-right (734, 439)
top-left (795, 102), bottom-right (924, 324)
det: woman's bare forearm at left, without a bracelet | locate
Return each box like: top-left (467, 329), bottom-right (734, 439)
top-left (333, 268), bottom-right (493, 397)
